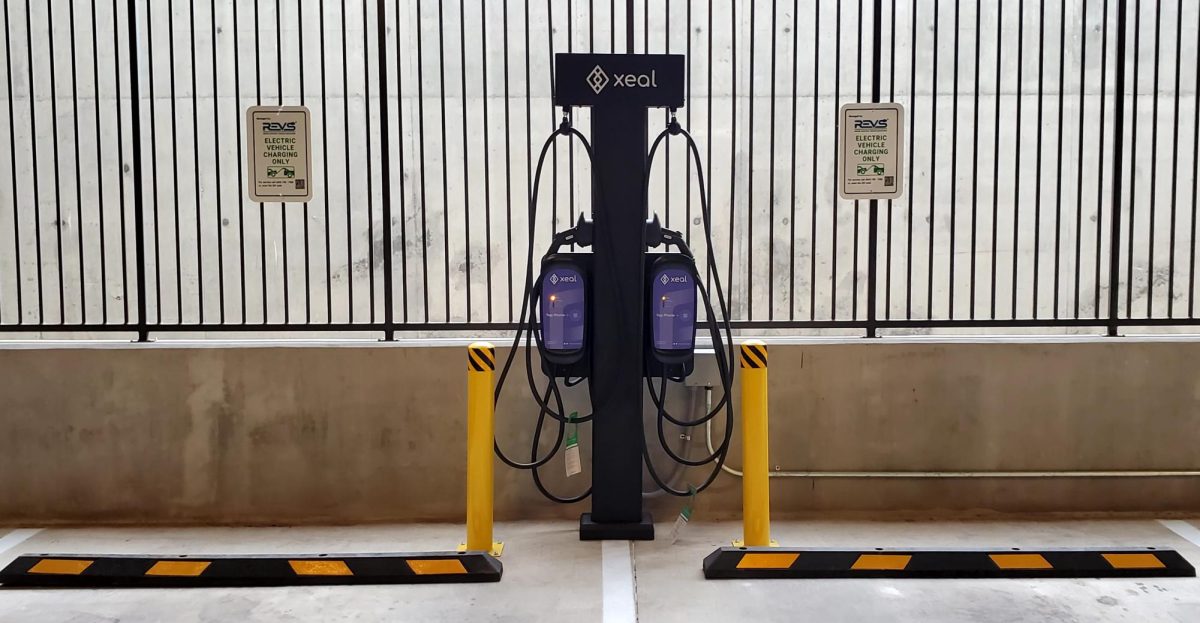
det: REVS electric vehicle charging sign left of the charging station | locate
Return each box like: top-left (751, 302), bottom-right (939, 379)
top-left (246, 106), bottom-right (312, 203)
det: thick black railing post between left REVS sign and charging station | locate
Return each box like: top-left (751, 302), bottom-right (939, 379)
top-left (374, 0), bottom-right (393, 341)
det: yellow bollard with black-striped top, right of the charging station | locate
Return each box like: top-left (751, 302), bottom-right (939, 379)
top-left (739, 340), bottom-right (773, 547)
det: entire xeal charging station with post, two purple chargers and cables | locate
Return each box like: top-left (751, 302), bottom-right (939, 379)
top-left (496, 54), bottom-right (733, 540)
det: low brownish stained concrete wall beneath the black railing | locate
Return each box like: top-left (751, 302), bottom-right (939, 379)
top-left (0, 339), bottom-right (1200, 525)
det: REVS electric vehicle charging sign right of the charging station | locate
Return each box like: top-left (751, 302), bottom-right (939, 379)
top-left (838, 103), bottom-right (904, 199)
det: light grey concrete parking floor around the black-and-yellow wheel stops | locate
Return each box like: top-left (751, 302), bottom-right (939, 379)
top-left (0, 520), bottom-right (1200, 623)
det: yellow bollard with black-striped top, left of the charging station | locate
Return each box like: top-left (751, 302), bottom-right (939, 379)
top-left (460, 342), bottom-right (504, 556)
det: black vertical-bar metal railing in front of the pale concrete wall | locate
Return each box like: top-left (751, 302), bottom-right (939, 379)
top-left (0, 0), bottom-right (1200, 340)
